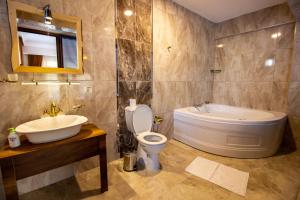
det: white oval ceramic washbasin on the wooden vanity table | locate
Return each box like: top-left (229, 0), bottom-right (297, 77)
top-left (16, 115), bottom-right (87, 144)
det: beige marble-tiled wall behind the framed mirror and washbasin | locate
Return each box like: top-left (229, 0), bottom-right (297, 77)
top-left (0, 0), bottom-right (118, 196)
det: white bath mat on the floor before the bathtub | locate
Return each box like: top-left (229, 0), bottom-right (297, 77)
top-left (185, 157), bottom-right (249, 196)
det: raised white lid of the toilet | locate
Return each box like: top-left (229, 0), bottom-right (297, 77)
top-left (132, 105), bottom-right (153, 135)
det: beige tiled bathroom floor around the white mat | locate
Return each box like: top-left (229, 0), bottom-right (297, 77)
top-left (21, 140), bottom-right (300, 200)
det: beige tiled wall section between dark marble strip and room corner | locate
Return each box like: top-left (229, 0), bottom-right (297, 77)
top-left (152, 0), bottom-right (215, 137)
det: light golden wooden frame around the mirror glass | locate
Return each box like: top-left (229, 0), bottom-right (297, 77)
top-left (7, 0), bottom-right (83, 74)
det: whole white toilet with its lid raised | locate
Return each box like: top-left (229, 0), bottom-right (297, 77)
top-left (125, 104), bottom-right (167, 172)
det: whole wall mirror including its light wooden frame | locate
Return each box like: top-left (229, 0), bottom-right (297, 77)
top-left (8, 1), bottom-right (83, 74)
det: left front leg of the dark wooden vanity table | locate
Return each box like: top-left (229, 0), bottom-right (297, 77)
top-left (0, 158), bottom-right (19, 200)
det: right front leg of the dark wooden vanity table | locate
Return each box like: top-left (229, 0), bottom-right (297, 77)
top-left (99, 136), bottom-right (108, 193)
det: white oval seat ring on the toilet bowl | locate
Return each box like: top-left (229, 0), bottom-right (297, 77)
top-left (137, 131), bottom-right (167, 145)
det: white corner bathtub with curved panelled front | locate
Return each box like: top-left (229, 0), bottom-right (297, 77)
top-left (174, 104), bottom-right (286, 158)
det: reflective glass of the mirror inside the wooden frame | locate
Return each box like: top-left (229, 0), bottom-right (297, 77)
top-left (17, 10), bottom-right (78, 69)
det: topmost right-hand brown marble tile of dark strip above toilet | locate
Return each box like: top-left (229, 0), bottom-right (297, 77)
top-left (135, 0), bottom-right (152, 44)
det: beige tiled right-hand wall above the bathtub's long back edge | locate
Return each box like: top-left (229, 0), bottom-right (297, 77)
top-left (213, 4), bottom-right (295, 112)
